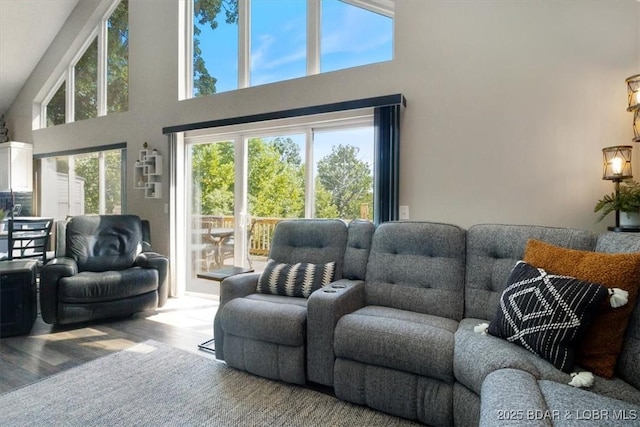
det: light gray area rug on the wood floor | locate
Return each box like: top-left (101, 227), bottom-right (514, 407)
top-left (0, 341), bottom-right (417, 427)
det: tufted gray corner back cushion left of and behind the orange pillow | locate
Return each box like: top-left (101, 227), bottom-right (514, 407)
top-left (464, 224), bottom-right (596, 320)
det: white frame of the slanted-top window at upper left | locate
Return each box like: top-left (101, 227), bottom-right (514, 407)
top-left (39, 0), bottom-right (123, 130)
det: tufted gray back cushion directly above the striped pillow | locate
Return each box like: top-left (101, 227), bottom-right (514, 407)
top-left (269, 219), bottom-right (347, 279)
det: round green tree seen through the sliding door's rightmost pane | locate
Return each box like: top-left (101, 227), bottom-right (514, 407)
top-left (316, 144), bottom-right (373, 219)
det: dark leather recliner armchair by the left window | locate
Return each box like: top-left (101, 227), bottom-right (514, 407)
top-left (40, 215), bottom-right (169, 324)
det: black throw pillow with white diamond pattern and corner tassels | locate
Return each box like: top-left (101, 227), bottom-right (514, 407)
top-left (488, 261), bottom-right (608, 372)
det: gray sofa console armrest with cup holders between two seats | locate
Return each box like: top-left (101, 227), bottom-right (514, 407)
top-left (307, 279), bottom-right (364, 386)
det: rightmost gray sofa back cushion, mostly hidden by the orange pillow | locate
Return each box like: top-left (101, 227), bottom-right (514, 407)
top-left (596, 233), bottom-right (640, 388)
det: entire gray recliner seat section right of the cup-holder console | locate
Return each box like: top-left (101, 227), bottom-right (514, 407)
top-left (334, 222), bottom-right (466, 425)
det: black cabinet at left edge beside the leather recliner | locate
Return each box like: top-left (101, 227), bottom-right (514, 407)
top-left (0, 260), bottom-right (38, 337)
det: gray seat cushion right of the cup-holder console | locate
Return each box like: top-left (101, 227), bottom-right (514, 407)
top-left (335, 306), bottom-right (458, 383)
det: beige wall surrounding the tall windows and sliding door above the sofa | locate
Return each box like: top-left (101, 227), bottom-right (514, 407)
top-left (7, 0), bottom-right (640, 253)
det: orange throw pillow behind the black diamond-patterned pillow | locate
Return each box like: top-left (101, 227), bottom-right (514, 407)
top-left (524, 239), bottom-right (640, 378)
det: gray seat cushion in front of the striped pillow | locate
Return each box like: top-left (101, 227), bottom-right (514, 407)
top-left (220, 295), bottom-right (307, 346)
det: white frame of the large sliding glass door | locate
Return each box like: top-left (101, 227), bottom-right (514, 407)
top-left (178, 113), bottom-right (378, 295)
